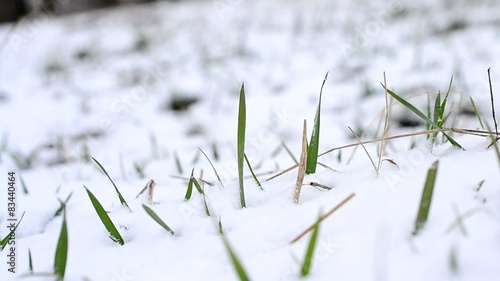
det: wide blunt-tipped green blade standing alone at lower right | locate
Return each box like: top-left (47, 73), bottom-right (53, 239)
top-left (413, 160), bottom-right (439, 235)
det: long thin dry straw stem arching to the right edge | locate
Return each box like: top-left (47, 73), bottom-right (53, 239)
top-left (266, 127), bottom-right (500, 181)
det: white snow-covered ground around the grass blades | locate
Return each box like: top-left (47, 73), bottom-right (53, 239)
top-left (0, 0), bottom-right (500, 281)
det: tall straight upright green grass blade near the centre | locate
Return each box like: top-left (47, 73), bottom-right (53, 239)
top-left (237, 84), bottom-right (247, 208)
